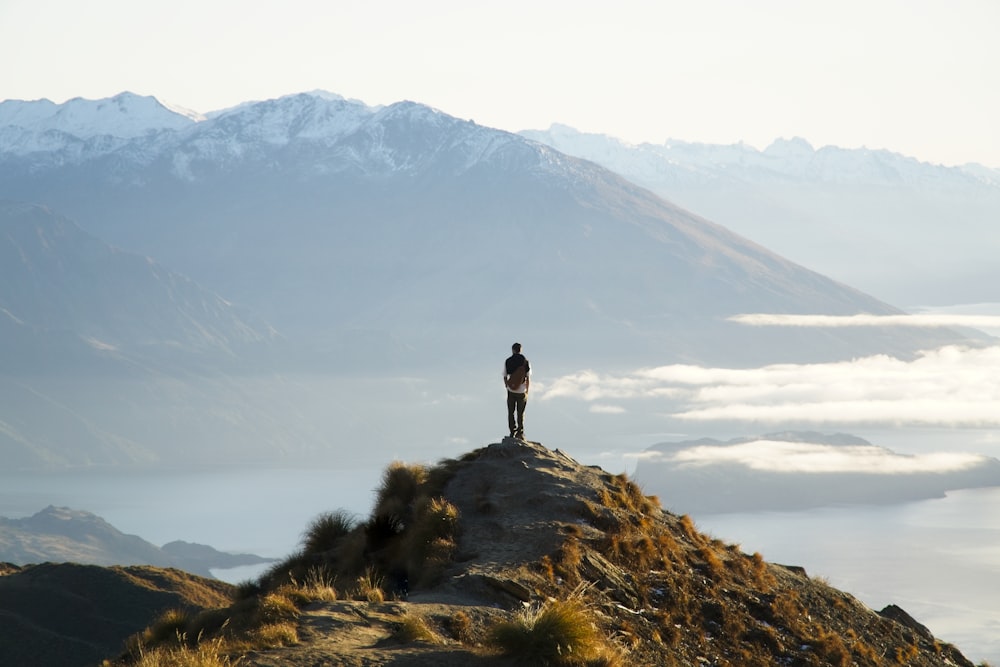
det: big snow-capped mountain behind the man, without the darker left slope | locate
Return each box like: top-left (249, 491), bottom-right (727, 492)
top-left (0, 95), bottom-right (972, 364)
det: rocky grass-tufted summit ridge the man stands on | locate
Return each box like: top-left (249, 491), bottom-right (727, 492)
top-left (101, 438), bottom-right (972, 667)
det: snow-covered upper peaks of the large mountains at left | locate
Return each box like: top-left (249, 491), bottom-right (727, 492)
top-left (0, 91), bottom-right (564, 181)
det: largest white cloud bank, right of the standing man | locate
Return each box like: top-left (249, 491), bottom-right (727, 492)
top-left (542, 346), bottom-right (1000, 427)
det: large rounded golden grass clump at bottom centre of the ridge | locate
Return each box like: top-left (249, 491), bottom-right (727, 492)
top-left (487, 597), bottom-right (620, 667)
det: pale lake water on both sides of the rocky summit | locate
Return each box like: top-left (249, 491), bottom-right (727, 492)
top-left (0, 468), bottom-right (1000, 664)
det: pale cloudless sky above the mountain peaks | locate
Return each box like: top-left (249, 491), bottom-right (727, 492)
top-left (0, 0), bottom-right (1000, 168)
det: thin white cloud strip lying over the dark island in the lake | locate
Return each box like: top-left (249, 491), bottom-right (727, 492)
top-left (664, 439), bottom-right (986, 475)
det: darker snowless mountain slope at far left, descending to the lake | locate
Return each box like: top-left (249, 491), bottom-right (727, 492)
top-left (0, 202), bottom-right (328, 469)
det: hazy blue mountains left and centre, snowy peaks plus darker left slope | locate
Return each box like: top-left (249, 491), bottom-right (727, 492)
top-left (0, 93), bottom-right (984, 466)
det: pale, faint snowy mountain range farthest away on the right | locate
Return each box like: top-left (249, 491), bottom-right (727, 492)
top-left (521, 124), bottom-right (1000, 307)
